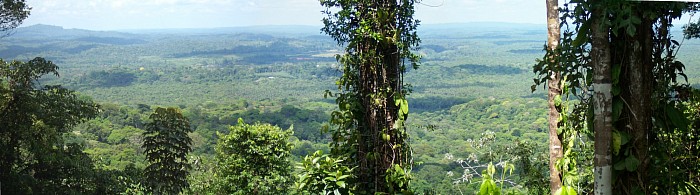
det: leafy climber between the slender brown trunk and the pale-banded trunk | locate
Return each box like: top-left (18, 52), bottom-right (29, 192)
top-left (531, 2), bottom-right (593, 193)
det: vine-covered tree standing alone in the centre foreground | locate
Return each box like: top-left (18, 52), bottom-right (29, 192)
top-left (320, 0), bottom-right (420, 193)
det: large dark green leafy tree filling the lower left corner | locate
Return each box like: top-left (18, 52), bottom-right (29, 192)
top-left (0, 58), bottom-right (140, 194)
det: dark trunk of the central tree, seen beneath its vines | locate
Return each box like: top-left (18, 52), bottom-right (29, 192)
top-left (358, 0), bottom-right (405, 192)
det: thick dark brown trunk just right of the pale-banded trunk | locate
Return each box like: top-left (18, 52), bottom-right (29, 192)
top-left (616, 6), bottom-right (654, 194)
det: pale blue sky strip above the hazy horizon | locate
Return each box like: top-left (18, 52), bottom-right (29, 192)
top-left (23, 0), bottom-right (546, 30)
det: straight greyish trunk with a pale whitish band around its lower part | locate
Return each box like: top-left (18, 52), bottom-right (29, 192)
top-left (590, 2), bottom-right (612, 195)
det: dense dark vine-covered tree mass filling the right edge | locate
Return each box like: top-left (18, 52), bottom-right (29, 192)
top-left (533, 1), bottom-right (698, 194)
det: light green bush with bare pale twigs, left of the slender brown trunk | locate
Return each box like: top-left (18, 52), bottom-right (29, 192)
top-left (441, 131), bottom-right (549, 194)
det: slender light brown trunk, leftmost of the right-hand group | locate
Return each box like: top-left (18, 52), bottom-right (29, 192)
top-left (546, 0), bottom-right (563, 194)
